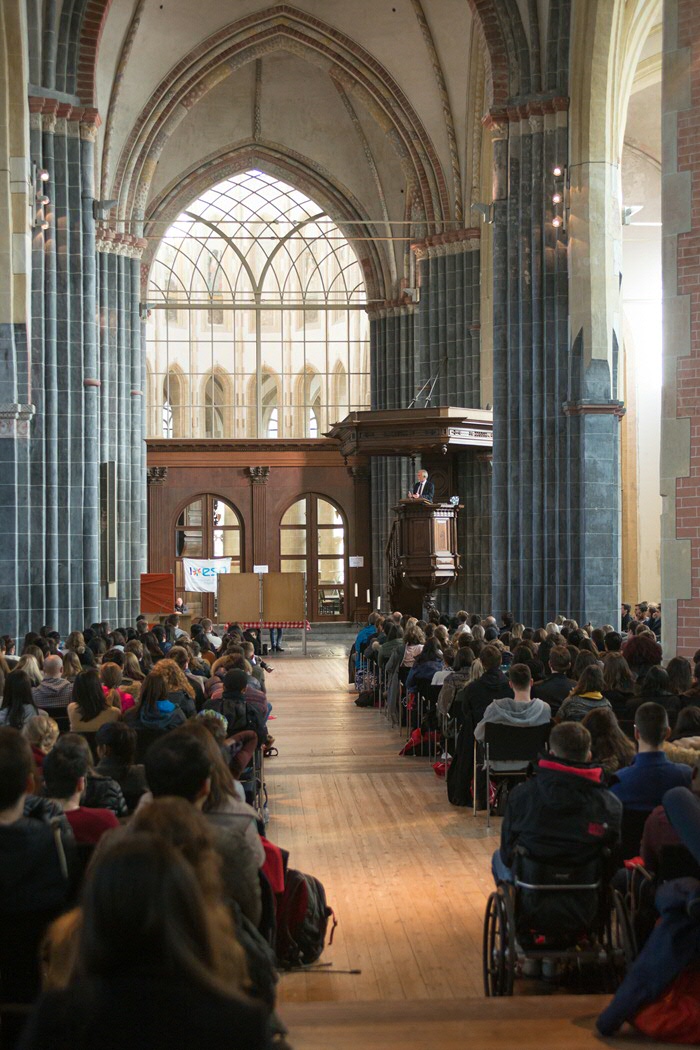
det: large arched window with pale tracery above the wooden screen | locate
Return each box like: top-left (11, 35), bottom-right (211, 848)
top-left (147, 171), bottom-right (369, 438)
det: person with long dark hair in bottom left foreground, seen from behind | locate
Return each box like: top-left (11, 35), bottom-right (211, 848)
top-left (23, 832), bottom-right (270, 1050)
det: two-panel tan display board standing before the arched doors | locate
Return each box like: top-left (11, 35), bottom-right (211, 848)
top-left (218, 572), bottom-right (304, 623)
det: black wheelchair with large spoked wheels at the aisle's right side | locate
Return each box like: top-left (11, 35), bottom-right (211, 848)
top-left (483, 851), bottom-right (637, 996)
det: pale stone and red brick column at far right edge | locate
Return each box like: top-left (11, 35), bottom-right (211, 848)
top-left (661, 0), bottom-right (700, 656)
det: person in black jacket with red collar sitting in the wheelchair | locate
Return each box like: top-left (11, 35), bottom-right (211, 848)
top-left (492, 722), bottom-right (622, 883)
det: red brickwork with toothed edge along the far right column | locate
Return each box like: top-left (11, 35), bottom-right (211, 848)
top-left (675, 0), bottom-right (700, 656)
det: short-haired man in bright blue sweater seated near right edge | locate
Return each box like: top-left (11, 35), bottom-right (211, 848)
top-left (610, 702), bottom-right (693, 813)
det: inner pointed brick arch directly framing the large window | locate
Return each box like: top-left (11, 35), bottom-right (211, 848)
top-left (142, 140), bottom-right (395, 299)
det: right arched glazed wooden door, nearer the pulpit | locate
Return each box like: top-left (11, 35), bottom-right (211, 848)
top-left (279, 492), bottom-right (347, 623)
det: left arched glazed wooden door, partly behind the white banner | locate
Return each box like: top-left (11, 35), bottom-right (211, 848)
top-left (174, 492), bottom-right (242, 622)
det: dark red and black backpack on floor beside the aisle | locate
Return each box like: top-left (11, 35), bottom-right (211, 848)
top-left (275, 867), bottom-right (338, 969)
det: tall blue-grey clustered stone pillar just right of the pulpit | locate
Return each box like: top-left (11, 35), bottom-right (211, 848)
top-left (484, 99), bottom-right (621, 626)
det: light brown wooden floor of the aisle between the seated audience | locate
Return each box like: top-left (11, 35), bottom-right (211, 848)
top-left (266, 657), bottom-right (659, 1050)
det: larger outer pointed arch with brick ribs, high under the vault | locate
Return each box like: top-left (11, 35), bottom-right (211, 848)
top-left (111, 4), bottom-right (450, 232)
